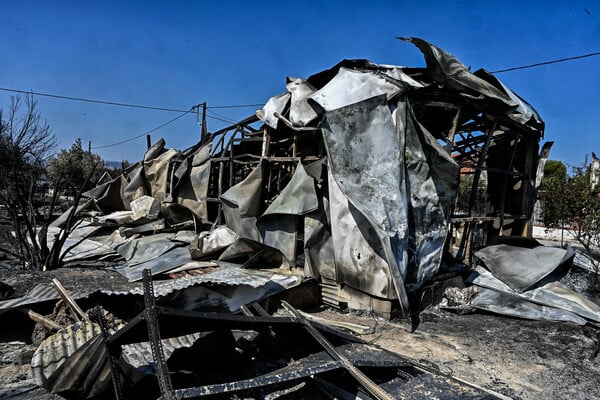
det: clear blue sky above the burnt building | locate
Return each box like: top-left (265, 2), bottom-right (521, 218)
top-left (0, 0), bottom-right (600, 165)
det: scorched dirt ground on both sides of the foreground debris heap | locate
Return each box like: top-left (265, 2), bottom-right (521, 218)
top-left (0, 268), bottom-right (600, 400)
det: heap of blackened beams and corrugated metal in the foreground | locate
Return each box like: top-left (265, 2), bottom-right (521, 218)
top-left (19, 271), bottom-right (502, 400)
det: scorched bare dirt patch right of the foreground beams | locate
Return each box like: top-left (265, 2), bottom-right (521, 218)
top-left (322, 310), bottom-right (600, 399)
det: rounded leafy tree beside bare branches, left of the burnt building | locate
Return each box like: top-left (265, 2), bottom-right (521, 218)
top-left (48, 138), bottom-right (105, 197)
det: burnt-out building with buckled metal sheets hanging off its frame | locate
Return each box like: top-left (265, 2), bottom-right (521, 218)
top-left (68, 38), bottom-right (544, 310)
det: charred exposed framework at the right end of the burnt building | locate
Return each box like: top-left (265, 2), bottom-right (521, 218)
top-left (411, 91), bottom-right (538, 263)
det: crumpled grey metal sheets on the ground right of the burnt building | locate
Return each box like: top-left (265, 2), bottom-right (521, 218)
top-left (467, 238), bottom-right (600, 325)
